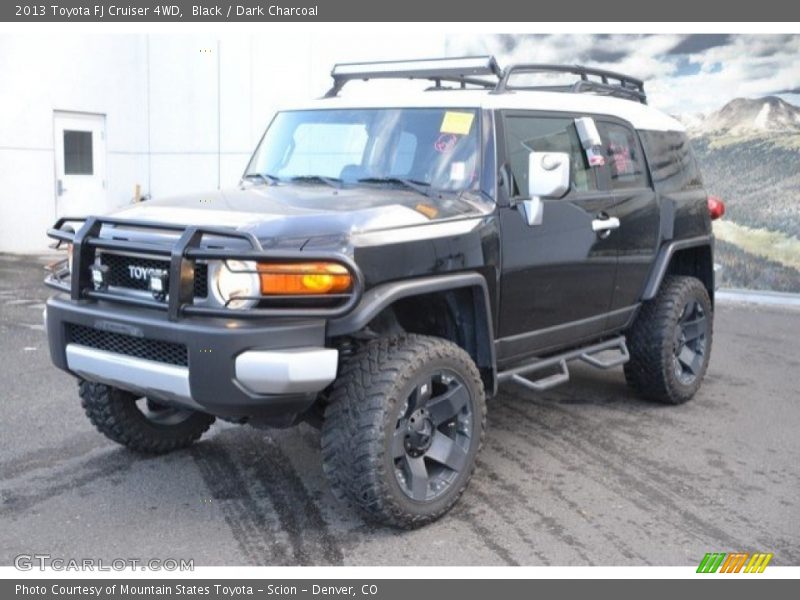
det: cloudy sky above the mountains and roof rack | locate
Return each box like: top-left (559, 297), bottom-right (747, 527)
top-left (447, 34), bottom-right (800, 114)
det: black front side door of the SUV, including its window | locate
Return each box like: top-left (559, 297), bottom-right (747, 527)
top-left (497, 112), bottom-right (617, 367)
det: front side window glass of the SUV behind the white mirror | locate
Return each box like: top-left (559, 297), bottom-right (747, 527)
top-left (505, 115), bottom-right (597, 196)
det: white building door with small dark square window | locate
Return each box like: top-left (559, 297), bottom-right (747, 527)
top-left (53, 111), bottom-right (107, 217)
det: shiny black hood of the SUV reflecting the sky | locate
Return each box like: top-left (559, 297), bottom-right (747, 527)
top-left (109, 184), bottom-right (492, 249)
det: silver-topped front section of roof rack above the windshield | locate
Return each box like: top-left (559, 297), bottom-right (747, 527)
top-left (325, 56), bottom-right (503, 98)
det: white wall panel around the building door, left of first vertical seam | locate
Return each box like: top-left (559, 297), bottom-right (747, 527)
top-left (0, 36), bottom-right (147, 251)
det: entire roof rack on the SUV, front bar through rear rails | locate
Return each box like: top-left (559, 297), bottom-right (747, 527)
top-left (325, 56), bottom-right (647, 104)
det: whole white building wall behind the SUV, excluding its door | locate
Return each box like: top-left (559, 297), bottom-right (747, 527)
top-left (0, 32), bottom-right (445, 253)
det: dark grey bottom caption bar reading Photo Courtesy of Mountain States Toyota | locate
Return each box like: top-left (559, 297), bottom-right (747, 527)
top-left (6, 575), bottom-right (797, 600)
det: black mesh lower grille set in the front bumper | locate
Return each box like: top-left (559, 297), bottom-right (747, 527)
top-left (67, 323), bottom-right (189, 367)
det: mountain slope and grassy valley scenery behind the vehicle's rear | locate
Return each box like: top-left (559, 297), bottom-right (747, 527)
top-left (678, 96), bottom-right (800, 293)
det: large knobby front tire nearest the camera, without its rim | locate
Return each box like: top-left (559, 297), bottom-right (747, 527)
top-left (321, 335), bottom-right (486, 529)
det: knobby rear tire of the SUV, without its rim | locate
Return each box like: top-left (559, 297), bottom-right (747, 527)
top-left (624, 276), bottom-right (713, 404)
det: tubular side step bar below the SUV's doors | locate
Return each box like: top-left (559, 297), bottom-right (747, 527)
top-left (497, 335), bottom-right (631, 392)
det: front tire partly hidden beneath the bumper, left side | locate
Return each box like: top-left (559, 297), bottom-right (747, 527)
top-left (79, 381), bottom-right (214, 454)
